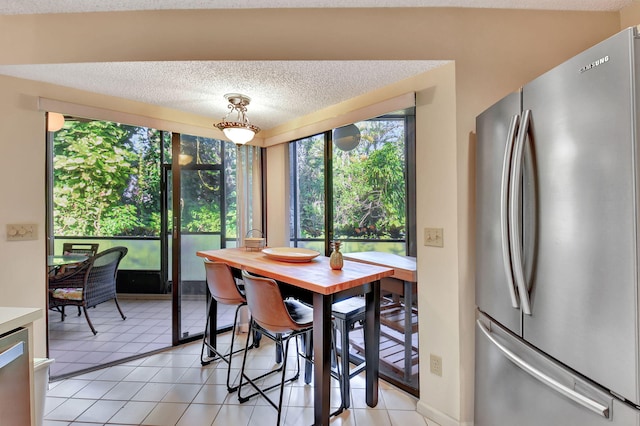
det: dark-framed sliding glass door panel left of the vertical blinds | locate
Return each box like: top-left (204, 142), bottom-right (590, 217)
top-left (165, 134), bottom-right (235, 344)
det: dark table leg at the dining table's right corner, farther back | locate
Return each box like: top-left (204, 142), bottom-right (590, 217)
top-left (364, 281), bottom-right (380, 407)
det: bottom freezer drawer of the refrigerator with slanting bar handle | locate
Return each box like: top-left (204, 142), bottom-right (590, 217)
top-left (474, 315), bottom-right (640, 426)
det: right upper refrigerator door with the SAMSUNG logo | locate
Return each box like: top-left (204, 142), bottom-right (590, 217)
top-left (523, 30), bottom-right (640, 404)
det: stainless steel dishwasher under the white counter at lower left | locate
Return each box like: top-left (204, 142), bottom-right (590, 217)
top-left (0, 328), bottom-right (31, 426)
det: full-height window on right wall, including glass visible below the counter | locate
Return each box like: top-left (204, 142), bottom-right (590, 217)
top-left (289, 109), bottom-right (419, 395)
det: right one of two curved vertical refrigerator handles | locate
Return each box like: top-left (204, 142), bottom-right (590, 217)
top-left (509, 110), bottom-right (531, 315)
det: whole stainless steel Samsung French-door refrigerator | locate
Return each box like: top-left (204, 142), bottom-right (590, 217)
top-left (475, 28), bottom-right (640, 426)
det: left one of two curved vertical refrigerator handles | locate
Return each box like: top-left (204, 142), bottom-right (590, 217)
top-left (500, 114), bottom-right (520, 309)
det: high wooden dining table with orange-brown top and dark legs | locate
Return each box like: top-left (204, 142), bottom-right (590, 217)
top-left (196, 248), bottom-right (393, 425)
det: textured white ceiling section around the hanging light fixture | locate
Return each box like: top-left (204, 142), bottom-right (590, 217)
top-left (0, 61), bottom-right (443, 129)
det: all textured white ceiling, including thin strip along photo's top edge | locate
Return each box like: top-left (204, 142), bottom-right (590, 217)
top-left (0, 0), bottom-right (633, 129)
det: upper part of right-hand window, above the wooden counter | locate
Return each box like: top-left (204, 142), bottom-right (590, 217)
top-left (289, 110), bottom-right (415, 255)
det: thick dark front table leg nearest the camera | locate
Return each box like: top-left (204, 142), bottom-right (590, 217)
top-left (313, 293), bottom-right (332, 426)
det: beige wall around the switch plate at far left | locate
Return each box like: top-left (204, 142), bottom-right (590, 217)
top-left (0, 79), bottom-right (47, 357)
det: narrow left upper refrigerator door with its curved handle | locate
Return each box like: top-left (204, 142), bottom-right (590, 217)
top-left (476, 93), bottom-right (521, 333)
